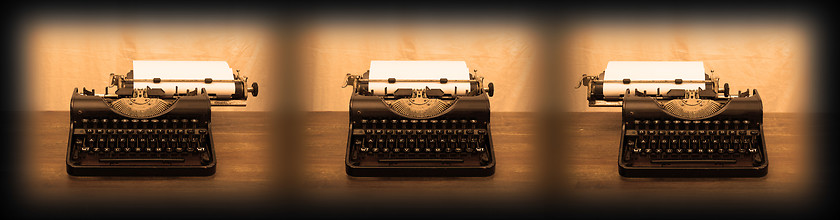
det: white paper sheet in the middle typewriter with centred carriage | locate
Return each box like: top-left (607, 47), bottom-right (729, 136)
top-left (368, 61), bottom-right (470, 95)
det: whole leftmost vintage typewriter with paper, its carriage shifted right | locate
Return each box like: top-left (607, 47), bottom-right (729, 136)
top-left (67, 61), bottom-right (259, 176)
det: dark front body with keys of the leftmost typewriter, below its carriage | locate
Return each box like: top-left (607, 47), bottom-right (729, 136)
top-left (67, 95), bottom-right (216, 175)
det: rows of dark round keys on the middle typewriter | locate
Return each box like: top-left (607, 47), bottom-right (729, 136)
top-left (349, 120), bottom-right (491, 166)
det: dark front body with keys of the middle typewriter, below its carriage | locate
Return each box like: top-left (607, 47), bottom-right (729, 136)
top-left (346, 95), bottom-right (495, 176)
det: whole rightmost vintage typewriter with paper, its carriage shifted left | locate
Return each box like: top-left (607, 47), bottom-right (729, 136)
top-left (578, 61), bottom-right (768, 177)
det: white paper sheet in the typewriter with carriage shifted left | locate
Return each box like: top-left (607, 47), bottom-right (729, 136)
top-left (604, 61), bottom-right (706, 97)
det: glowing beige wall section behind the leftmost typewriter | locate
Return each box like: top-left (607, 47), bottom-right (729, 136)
top-left (22, 16), bottom-right (276, 111)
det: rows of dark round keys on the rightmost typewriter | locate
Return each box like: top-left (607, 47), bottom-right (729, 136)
top-left (622, 120), bottom-right (764, 167)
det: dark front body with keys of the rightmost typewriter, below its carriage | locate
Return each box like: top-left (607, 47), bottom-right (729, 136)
top-left (619, 96), bottom-right (768, 177)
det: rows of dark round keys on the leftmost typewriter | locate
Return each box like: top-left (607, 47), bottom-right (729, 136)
top-left (69, 119), bottom-right (212, 165)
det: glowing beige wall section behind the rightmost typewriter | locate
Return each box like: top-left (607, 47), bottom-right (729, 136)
top-left (561, 18), bottom-right (813, 112)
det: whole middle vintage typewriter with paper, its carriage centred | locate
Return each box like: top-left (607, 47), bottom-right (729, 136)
top-left (344, 61), bottom-right (496, 176)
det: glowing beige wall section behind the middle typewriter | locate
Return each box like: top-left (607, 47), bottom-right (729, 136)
top-left (299, 18), bottom-right (537, 112)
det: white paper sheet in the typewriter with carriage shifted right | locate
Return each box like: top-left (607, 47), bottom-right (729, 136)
top-left (134, 60), bottom-right (236, 95)
